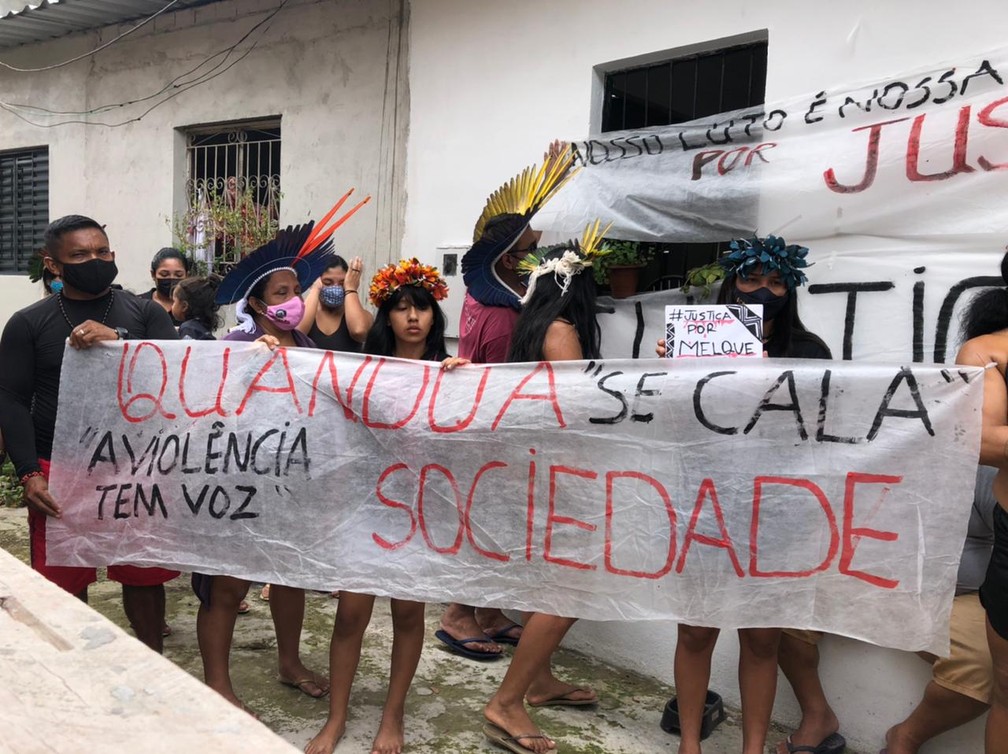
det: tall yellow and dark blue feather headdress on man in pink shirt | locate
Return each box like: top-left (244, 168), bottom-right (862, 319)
top-left (462, 150), bottom-right (577, 308)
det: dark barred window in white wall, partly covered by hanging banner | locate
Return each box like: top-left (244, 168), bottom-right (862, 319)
top-left (602, 39), bottom-right (767, 290)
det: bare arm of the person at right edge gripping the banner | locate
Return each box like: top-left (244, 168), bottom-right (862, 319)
top-left (956, 336), bottom-right (1008, 469)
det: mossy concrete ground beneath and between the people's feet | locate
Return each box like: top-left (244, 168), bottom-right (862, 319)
top-left (0, 507), bottom-right (855, 754)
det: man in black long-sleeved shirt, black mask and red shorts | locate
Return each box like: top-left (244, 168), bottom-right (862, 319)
top-left (0, 215), bottom-right (177, 652)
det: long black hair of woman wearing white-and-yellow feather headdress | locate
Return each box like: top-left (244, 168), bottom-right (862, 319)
top-left (507, 246), bottom-right (602, 361)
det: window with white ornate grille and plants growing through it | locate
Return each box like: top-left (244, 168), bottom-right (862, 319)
top-left (182, 119), bottom-right (281, 271)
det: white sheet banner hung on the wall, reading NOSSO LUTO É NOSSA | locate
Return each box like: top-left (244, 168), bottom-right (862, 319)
top-left (535, 49), bottom-right (1008, 362)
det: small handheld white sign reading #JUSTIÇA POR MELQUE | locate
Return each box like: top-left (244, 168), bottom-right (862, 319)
top-left (665, 303), bottom-right (763, 359)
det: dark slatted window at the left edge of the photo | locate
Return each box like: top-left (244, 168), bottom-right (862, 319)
top-left (0, 147), bottom-right (49, 274)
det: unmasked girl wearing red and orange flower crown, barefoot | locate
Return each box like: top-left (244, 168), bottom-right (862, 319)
top-left (304, 259), bottom-right (467, 754)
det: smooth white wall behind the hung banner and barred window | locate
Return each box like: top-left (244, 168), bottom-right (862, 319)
top-left (403, 0), bottom-right (1008, 752)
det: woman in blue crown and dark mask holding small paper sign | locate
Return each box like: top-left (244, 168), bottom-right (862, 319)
top-left (656, 236), bottom-right (830, 754)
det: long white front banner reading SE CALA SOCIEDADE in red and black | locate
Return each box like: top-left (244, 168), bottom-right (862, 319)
top-left (47, 342), bottom-right (983, 653)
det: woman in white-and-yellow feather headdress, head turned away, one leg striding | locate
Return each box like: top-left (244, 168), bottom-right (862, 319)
top-left (483, 222), bottom-right (609, 752)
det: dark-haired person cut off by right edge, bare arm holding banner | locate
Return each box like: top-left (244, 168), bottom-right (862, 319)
top-left (956, 254), bottom-right (1008, 754)
